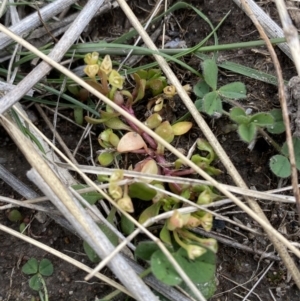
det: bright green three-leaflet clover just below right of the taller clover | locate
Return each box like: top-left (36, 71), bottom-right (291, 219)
top-left (229, 107), bottom-right (274, 143)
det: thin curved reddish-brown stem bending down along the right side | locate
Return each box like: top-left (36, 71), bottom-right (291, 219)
top-left (242, 0), bottom-right (300, 289)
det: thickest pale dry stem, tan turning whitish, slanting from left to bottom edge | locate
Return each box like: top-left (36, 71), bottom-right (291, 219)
top-left (0, 111), bottom-right (156, 301)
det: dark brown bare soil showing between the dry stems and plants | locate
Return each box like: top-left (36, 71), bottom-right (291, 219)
top-left (0, 0), bottom-right (300, 301)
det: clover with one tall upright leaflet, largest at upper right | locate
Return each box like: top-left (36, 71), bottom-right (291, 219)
top-left (193, 59), bottom-right (247, 116)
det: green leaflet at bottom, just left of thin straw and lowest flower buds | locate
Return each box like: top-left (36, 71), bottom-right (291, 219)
top-left (151, 250), bottom-right (182, 285)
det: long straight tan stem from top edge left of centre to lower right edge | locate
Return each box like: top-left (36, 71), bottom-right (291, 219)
top-left (118, 0), bottom-right (300, 288)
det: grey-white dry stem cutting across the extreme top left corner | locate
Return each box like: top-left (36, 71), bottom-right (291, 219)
top-left (0, 0), bottom-right (77, 50)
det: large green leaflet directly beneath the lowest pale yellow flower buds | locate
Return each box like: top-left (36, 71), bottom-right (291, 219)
top-left (174, 248), bottom-right (216, 283)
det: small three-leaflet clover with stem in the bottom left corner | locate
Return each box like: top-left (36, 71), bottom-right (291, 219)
top-left (22, 258), bottom-right (53, 301)
